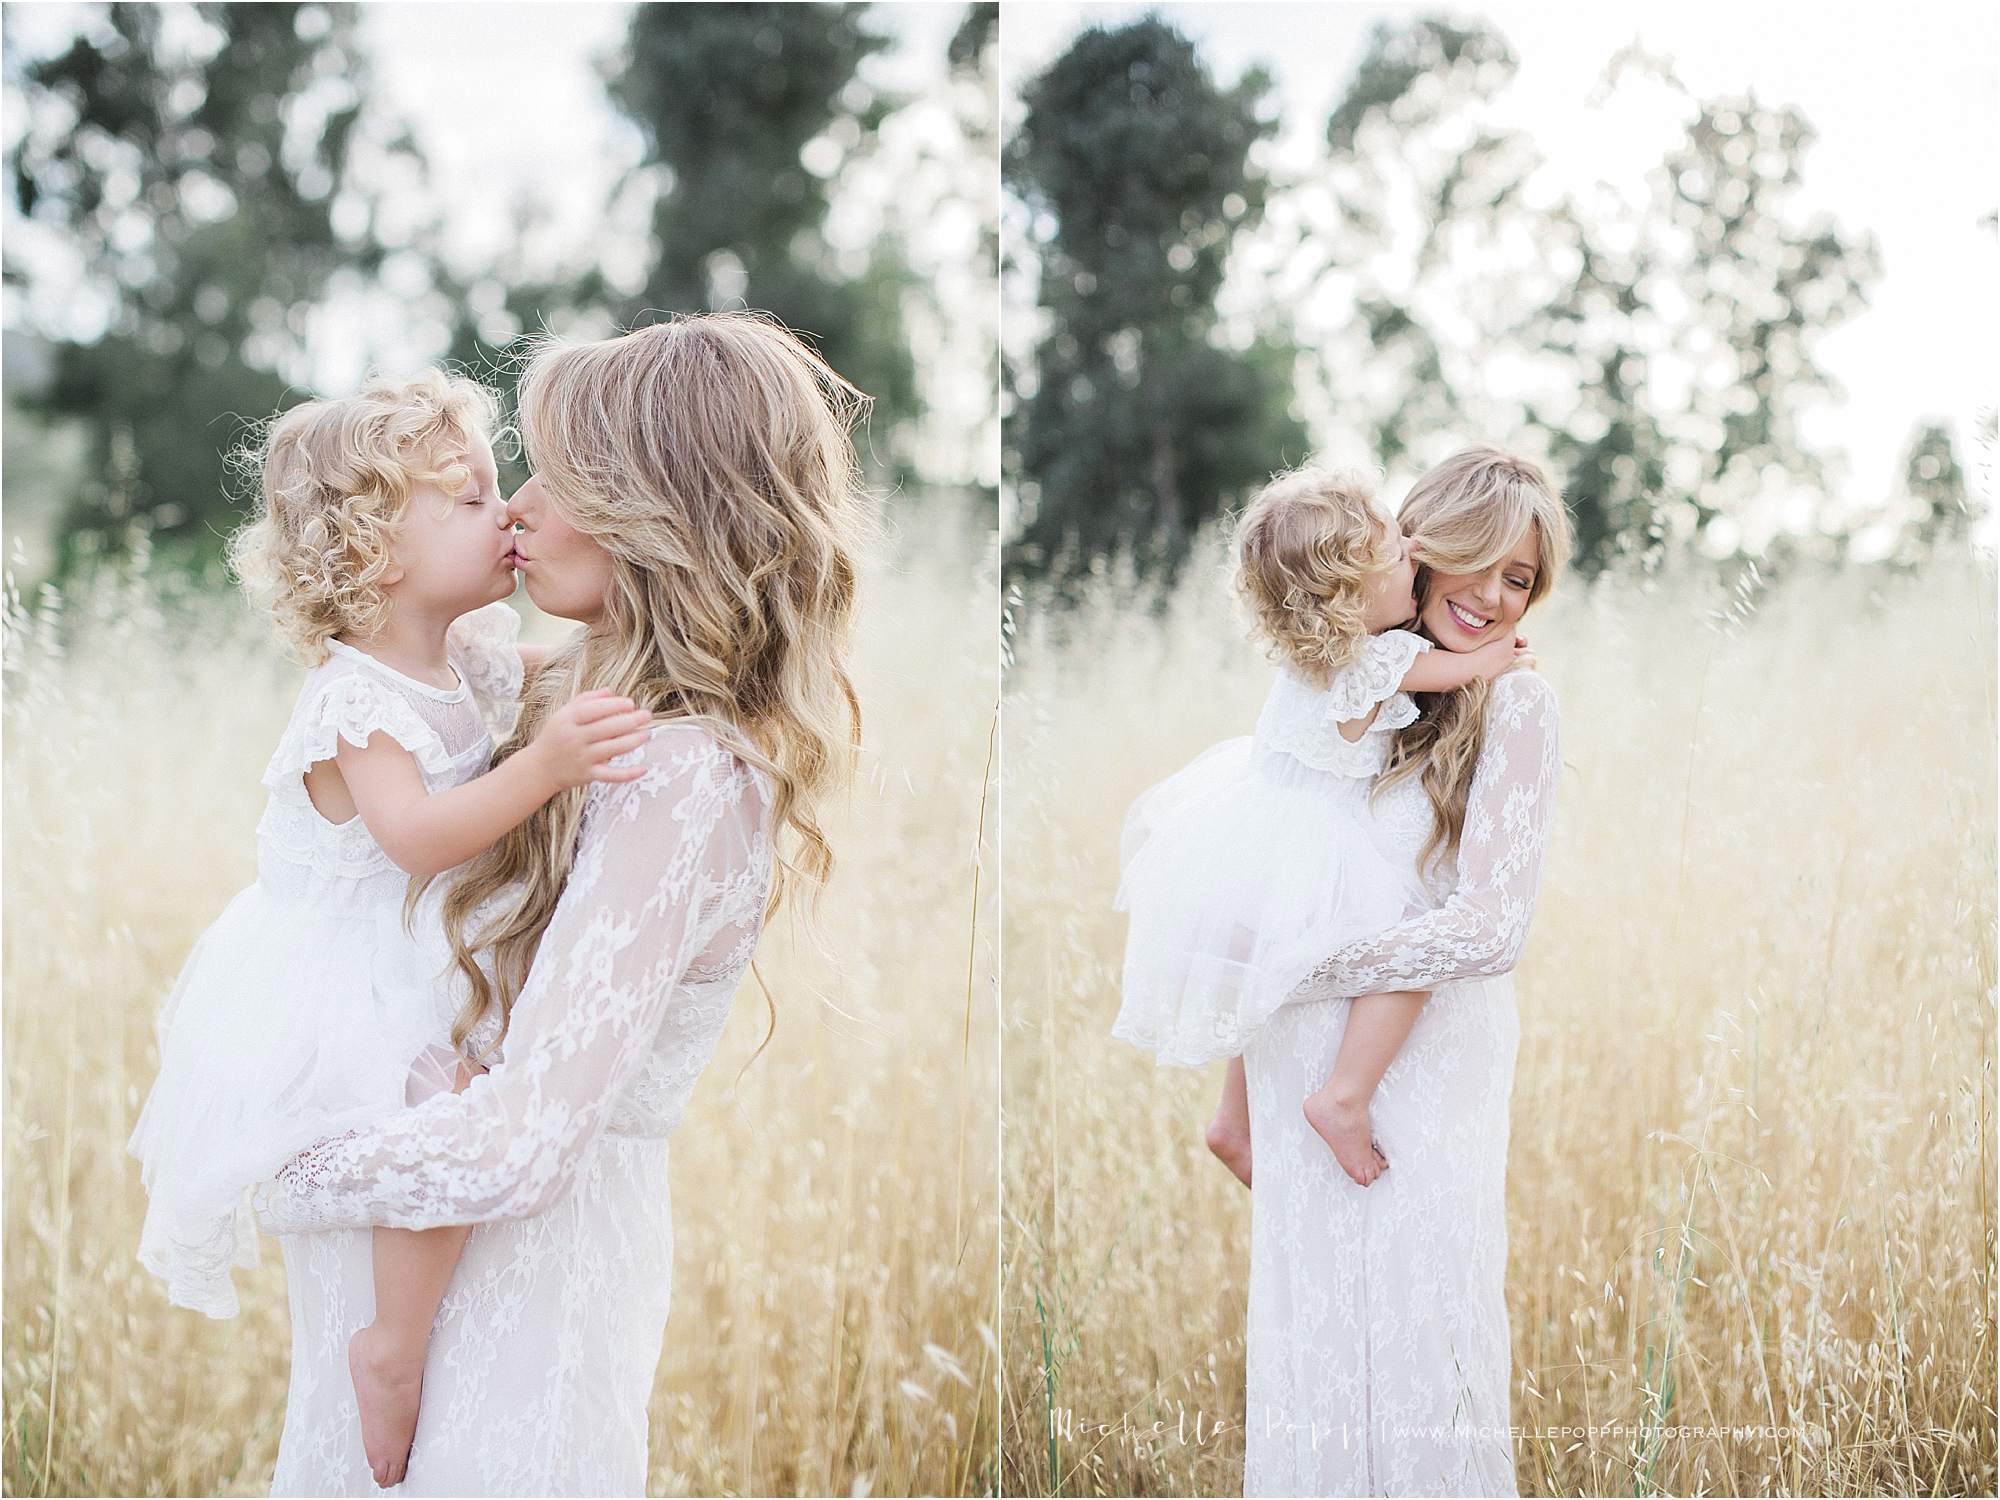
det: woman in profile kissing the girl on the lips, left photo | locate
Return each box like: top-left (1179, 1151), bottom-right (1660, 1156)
top-left (258, 316), bottom-right (860, 1494)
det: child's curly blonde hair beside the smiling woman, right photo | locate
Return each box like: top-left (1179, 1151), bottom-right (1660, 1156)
top-left (1232, 464), bottom-right (1402, 684)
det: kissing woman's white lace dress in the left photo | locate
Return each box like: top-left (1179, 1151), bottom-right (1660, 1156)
top-left (258, 720), bottom-right (772, 1496)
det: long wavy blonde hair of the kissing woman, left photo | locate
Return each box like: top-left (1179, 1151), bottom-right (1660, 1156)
top-left (426, 312), bottom-right (872, 1046)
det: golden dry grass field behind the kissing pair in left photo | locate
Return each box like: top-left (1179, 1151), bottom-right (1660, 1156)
top-left (4, 528), bottom-right (998, 1494)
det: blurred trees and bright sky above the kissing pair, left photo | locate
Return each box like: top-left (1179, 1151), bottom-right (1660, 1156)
top-left (0, 4), bottom-right (998, 580)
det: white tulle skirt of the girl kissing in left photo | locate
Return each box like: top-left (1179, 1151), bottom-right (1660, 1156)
top-left (130, 876), bottom-right (450, 1318)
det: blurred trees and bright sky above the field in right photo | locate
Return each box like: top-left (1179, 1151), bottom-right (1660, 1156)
top-left (1002, 4), bottom-right (2000, 580)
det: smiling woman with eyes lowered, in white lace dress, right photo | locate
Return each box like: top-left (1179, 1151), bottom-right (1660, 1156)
top-left (1244, 448), bottom-right (1570, 1494)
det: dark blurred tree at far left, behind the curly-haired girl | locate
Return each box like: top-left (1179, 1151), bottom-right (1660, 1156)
top-left (6, 4), bottom-right (414, 568)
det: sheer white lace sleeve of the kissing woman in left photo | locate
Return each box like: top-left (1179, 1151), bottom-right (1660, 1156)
top-left (256, 724), bottom-right (770, 1234)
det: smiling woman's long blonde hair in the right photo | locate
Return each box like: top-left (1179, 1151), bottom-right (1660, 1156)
top-left (1370, 446), bottom-right (1572, 888)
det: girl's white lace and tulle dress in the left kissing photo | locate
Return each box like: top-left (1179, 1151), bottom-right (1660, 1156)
top-left (130, 602), bottom-right (520, 1318)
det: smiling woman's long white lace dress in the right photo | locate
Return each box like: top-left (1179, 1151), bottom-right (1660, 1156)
top-left (1244, 670), bottom-right (1562, 1496)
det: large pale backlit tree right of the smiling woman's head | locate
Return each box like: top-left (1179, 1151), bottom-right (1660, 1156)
top-left (1526, 50), bottom-right (1878, 572)
